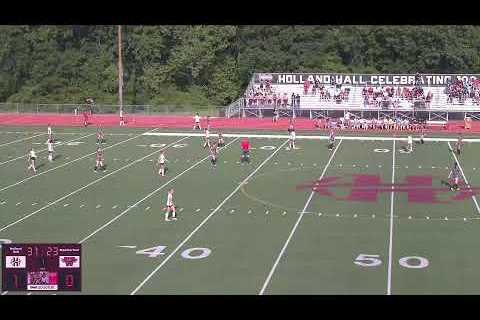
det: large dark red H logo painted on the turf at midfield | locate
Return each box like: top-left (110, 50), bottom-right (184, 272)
top-left (297, 174), bottom-right (480, 203)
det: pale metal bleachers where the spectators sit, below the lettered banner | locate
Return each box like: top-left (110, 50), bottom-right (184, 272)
top-left (232, 74), bottom-right (480, 121)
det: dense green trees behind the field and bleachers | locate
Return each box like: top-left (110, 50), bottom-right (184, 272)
top-left (0, 25), bottom-right (480, 106)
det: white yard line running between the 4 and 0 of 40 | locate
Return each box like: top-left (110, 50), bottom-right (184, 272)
top-left (130, 140), bottom-right (288, 295)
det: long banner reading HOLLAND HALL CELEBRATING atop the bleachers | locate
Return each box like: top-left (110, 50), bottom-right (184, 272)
top-left (254, 73), bottom-right (480, 86)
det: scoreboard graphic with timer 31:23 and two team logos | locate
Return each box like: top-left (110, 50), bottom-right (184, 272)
top-left (2, 243), bottom-right (82, 291)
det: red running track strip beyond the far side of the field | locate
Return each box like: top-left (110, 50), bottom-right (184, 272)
top-left (0, 113), bottom-right (480, 134)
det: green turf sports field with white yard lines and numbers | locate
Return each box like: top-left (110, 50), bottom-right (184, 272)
top-left (0, 127), bottom-right (480, 295)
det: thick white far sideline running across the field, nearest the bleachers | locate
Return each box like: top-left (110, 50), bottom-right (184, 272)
top-left (144, 132), bottom-right (480, 142)
